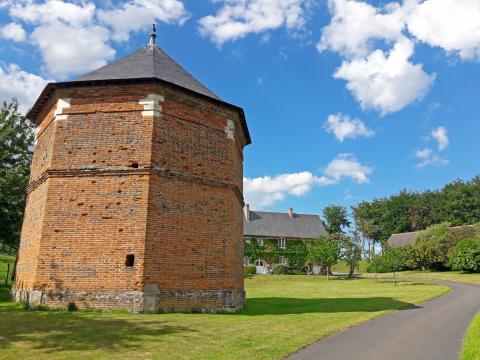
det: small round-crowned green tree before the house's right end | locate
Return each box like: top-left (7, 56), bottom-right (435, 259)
top-left (306, 236), bottom-right (340, 279)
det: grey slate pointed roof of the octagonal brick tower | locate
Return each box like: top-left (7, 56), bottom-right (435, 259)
top-left (74, 45), bottom-right (220, 100)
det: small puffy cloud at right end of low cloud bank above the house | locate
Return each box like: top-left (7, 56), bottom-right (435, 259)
top-left (324, 154), bottom-right (373, 184)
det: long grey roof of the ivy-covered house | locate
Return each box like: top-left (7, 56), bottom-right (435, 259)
top-left (243, 211), bottom-right (327, 239)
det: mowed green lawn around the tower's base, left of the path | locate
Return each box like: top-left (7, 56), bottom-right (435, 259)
top-left (0, 275), bottom-right (449, 360)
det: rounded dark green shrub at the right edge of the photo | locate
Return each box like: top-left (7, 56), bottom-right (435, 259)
top-left (450, 238), bottom-right (480, 272)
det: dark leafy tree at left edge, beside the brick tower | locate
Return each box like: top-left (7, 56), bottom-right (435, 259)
top-left (0, 100), bottom-right (34, 250)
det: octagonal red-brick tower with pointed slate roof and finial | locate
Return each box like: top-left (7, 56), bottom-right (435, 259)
top-left (12, 28), bottom-right (250, 312)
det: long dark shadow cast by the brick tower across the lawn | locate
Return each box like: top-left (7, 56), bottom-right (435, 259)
top-left (236, 297), bottom-right (418, 316)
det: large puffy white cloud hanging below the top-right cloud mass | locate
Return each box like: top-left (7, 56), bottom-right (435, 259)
top-left (334, 38), bottom-right (435, 115)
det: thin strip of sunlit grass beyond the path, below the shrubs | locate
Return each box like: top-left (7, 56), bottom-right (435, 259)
top-left (362, 271), bottom-right (480, 285)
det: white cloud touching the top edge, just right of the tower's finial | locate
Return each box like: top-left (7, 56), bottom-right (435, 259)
top-left (199, 0), bottom-right (311, 45)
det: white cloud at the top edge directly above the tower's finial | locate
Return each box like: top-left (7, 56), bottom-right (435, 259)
top-left (98, 0), bottom-right (189, 41)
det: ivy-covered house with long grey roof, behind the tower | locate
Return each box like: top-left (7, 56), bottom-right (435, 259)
top-left (243, 204), bottom-right (327, 274)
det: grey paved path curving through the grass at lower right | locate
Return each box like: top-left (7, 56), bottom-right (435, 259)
top-left (289, 283), bottom-right (480, 360)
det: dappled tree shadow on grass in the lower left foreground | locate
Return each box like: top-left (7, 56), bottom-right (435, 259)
top-left (0, 286), bottom-right (197, 352)
